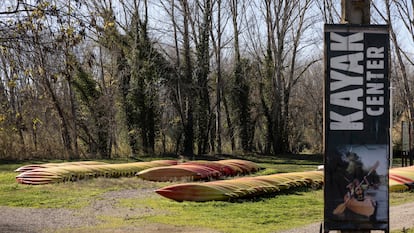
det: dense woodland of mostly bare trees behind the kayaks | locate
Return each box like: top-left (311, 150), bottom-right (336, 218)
top-left (0, 0), bottom-right (414, 159)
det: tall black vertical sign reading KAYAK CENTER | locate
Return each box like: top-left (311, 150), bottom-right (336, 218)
top-left (324, 24), bottom-right (390, 232)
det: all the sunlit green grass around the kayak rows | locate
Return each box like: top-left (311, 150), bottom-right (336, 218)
top-left (0, 155), bottom-right (414, 233)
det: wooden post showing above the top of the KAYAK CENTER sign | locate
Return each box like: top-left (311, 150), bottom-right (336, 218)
top-left (341, 0), bottom-right (371, 233)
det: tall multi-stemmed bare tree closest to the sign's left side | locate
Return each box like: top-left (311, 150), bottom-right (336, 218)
top-left (260, 0), bottom-right (316, 153)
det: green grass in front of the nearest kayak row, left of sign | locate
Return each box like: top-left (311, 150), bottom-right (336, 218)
top-left (120, 190), bottom-right (323, 233)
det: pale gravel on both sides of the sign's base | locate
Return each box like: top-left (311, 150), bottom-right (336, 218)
top-left (280, 203), bottom-right (414, 233)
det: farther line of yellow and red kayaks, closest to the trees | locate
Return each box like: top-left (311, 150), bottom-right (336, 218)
top-left (15, 159), bottom-right (261, 185)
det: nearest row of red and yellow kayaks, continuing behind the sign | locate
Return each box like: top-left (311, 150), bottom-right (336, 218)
top-left (156, 166), bottom-right (414, 202)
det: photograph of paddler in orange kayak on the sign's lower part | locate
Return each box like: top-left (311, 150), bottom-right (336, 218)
top-left (327, 145), bottom-right (388, 222)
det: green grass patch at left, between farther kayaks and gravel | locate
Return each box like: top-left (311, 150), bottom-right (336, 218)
top-left (0, 161), bottom-right (165, 208)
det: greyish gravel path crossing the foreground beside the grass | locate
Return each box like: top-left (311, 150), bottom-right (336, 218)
top-left (0, 189), bottom-right (414, 233)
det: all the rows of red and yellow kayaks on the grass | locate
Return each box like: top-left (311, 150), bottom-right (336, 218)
top-left (12, 159), bottom-right (414, 201)
